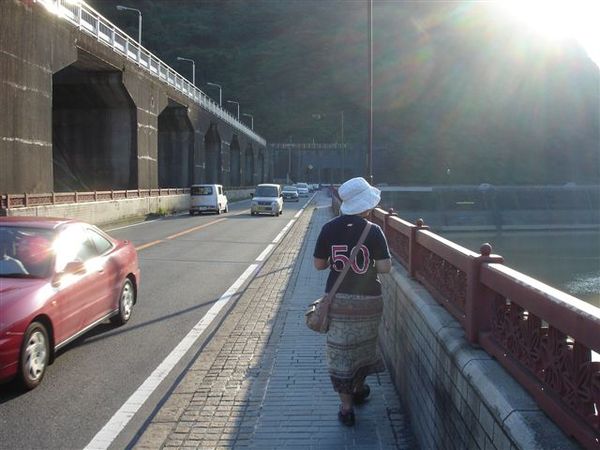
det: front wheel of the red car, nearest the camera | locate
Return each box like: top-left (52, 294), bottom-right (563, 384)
top-left (19, 322), bottom-right (50, 390)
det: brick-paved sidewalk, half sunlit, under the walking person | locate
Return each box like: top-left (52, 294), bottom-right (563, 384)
top-left (136, 193), bottom-right (416, 449)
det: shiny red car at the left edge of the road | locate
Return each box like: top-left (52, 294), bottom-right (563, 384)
top-left (0, 217), bottom-right (140, 389)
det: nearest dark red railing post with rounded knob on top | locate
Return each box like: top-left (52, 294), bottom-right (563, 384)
top-left (465, 243), bottom-right (504, 344)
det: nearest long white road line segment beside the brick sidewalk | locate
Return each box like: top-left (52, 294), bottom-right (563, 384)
top-left (85, 264), bottom-right (259, 450)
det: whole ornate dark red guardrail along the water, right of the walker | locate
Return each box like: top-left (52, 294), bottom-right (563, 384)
top-left (332, 190), bottom-right (600, 449)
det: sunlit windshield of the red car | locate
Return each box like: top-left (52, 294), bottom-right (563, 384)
top-left (0, 226), bottom-right (54, 278)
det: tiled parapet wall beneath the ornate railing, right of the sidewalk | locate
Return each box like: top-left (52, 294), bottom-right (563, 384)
top-left (380, 264), bottom-right (580, 450)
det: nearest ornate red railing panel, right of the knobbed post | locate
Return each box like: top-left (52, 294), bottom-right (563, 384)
top-left (479, 264), bottom-right (600, 448)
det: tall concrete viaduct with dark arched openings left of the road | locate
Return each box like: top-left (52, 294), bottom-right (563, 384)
top-left (0, 0), bottom-right (272, 193)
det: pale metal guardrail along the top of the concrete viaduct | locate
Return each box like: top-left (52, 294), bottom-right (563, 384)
top-left (38, 0), bottom-right (266, 145)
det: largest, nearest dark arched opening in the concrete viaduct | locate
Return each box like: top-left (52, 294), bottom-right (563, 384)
top-left (52, 61), bottom-right (138, 192)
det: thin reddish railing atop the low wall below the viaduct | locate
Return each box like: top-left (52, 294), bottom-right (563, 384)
top-left (0, 188), bottom-right (190, 209)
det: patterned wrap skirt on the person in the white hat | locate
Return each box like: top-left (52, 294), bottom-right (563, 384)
top-left (326, 293), bottom-right (385, 394)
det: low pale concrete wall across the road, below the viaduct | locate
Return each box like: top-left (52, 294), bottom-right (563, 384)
top-left (4, 189), bottom-right (254, 225)
